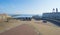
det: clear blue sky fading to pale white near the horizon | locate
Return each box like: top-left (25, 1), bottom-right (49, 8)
top-left (0, 0), bottom-right (60, 14)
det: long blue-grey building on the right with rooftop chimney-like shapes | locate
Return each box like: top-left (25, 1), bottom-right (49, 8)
top-left (42, 8), bottom-right (60, 19)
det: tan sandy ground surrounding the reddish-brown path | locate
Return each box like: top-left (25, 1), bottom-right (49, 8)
top-left (0, 19), bottom-right (60, 35)
